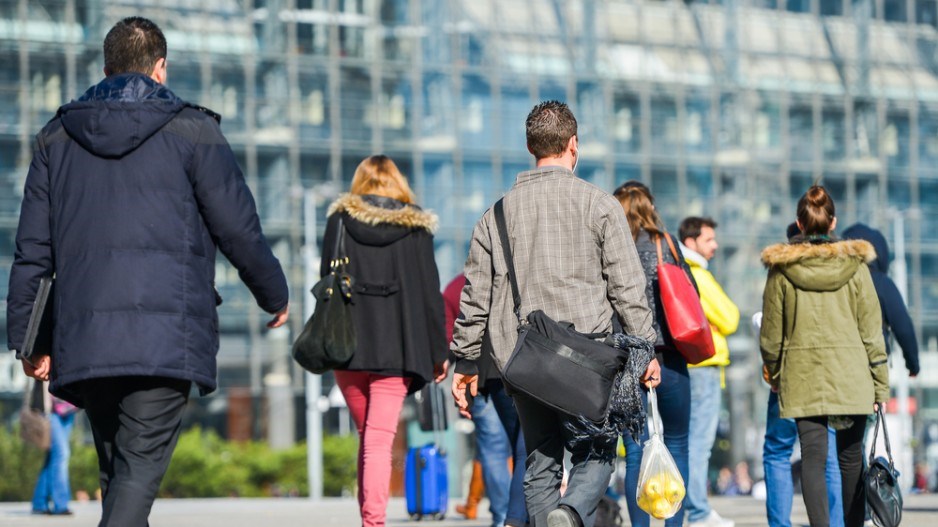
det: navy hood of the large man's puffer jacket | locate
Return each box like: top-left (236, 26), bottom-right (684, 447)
top-left (56, 73), bottom-right (187, 159)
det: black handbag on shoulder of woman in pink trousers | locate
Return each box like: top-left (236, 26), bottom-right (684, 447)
top-left (293, 216), bottom-right (357, 374)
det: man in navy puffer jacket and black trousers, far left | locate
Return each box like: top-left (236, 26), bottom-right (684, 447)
top-left (7, 17), bottom-right (289, 527)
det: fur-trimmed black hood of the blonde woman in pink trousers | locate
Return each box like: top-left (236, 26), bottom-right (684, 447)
top-left (328, 194), bottom-right (438, 247)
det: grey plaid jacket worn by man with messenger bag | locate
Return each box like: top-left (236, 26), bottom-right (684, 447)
top-left (450, 167), bottom-right (656, 373)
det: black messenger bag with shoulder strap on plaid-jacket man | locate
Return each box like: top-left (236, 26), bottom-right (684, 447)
top-left (495, 200), bottom-right (625, 423)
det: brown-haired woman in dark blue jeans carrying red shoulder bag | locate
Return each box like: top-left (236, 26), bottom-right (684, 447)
top-left (615, 181), bottom-right (694, 527)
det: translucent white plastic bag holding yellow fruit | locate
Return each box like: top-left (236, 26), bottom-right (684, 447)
top-left (635, 388), bottom-right (686, 520)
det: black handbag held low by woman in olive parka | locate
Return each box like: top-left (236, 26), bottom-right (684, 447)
top-left (863, 404), bottom-right (902, 527)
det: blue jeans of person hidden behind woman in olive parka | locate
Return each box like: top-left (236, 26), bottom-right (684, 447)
top-left (762, 392), bottom-right (844, 527)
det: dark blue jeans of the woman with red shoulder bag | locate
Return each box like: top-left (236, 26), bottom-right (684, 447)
top-left (622, 351), bottom-right (690, 527)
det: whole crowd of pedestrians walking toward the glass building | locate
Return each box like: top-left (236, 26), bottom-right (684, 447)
top-left (7, 13), bottom-right (919, 527)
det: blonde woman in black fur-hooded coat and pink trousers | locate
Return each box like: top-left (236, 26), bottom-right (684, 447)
top-left (320, 155), bottom-right (446, 527)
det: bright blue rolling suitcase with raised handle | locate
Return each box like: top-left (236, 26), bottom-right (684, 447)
top-left (404, 386), bottom-right (449, 520)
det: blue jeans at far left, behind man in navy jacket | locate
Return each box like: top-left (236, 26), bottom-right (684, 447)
top-left (33, 413), bottom-right (75, 513)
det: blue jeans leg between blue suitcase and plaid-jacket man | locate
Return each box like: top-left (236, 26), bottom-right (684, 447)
top-left (471, 394), bottom-right (511, 527)
